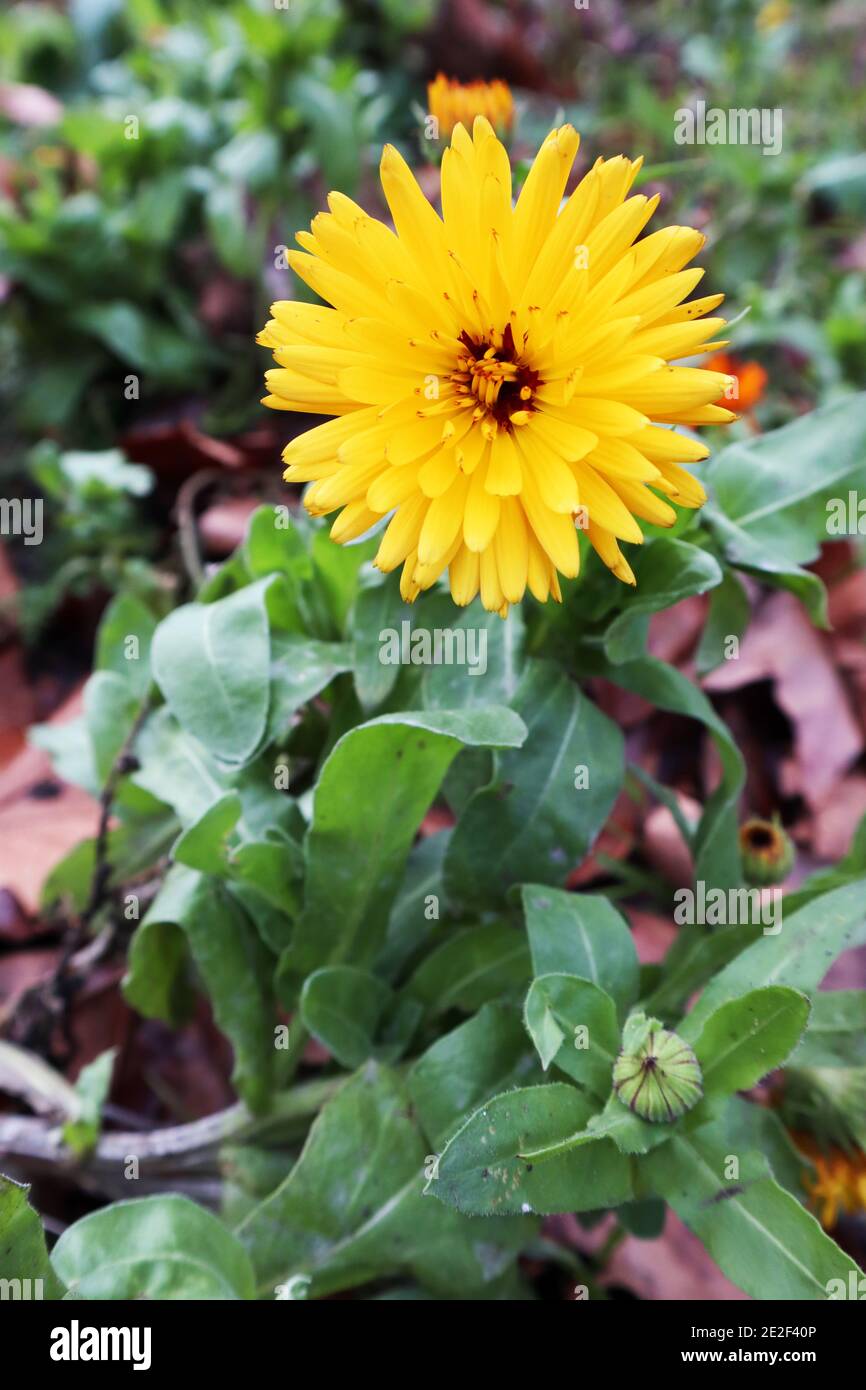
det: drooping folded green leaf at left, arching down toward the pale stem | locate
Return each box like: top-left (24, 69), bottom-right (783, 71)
top-left (124, 865), bottom-right (275, 1111)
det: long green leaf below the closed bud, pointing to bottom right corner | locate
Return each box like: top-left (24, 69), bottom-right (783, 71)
top-left (644, 1125), bottom-right (859, 1300)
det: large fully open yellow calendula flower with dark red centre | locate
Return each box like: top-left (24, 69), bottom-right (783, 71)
top-left (259, 118), bottom-right (734, 616)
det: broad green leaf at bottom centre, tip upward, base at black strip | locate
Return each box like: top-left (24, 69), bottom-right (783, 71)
top-left (238, 1063), bottom-right (534, 1298)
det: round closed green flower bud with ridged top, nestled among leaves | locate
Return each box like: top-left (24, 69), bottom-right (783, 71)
top-left (613, 1013), bottom-right (703, 1125)
